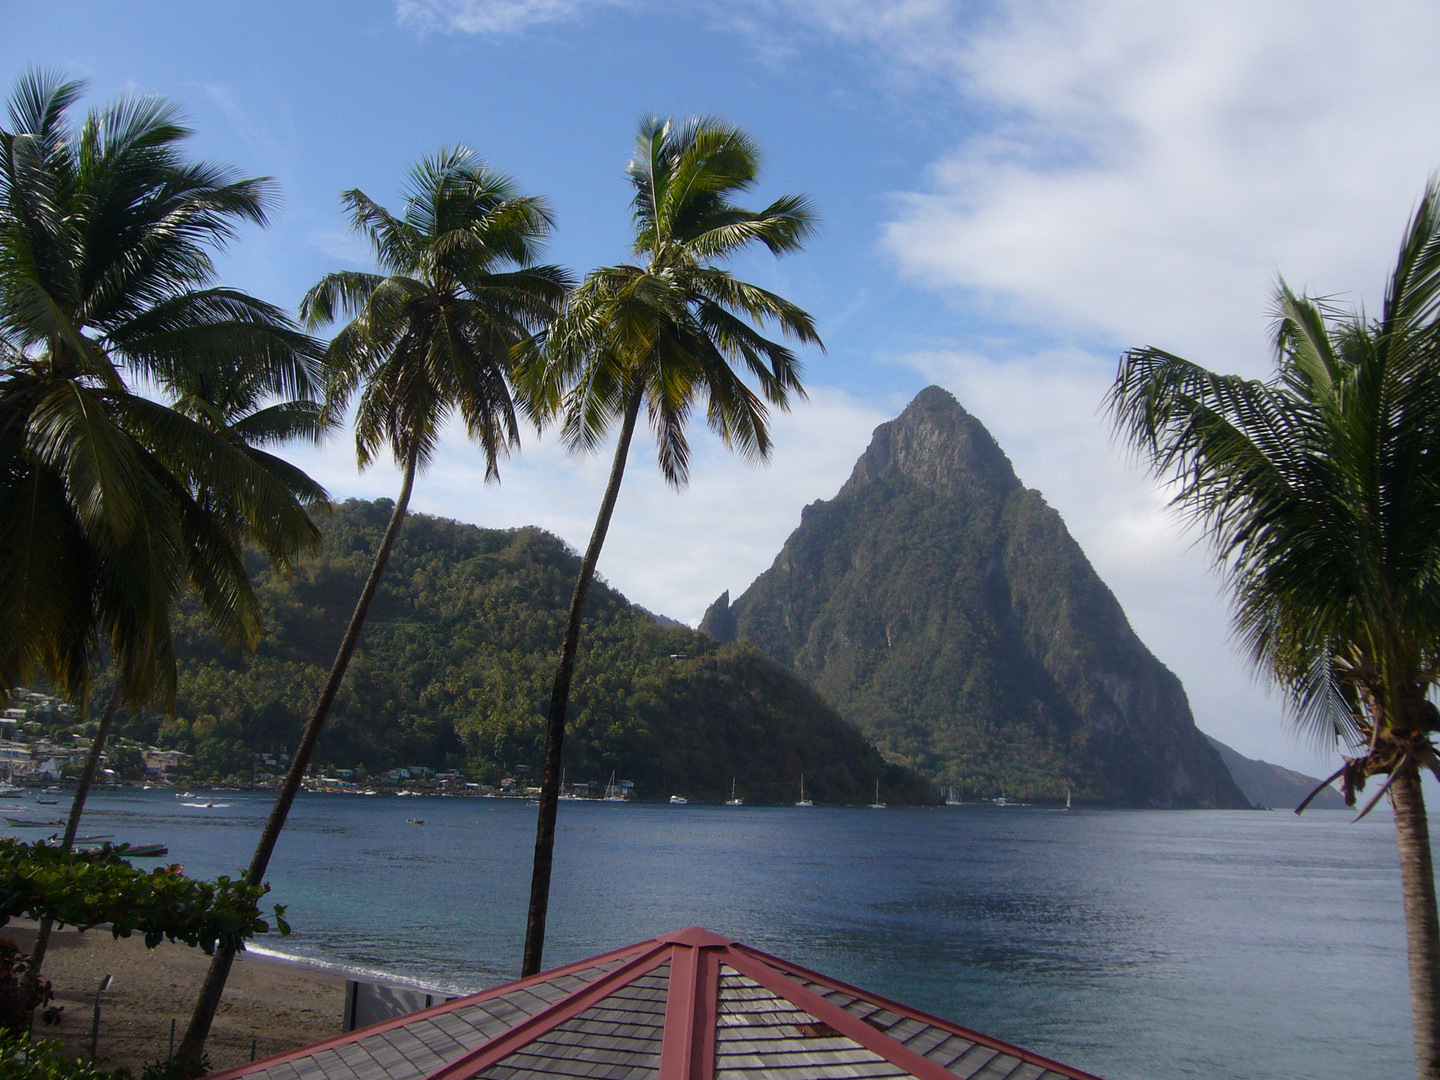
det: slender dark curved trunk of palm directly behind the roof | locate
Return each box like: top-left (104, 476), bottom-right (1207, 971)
top-left (520, 386), bottom-right (644, 978)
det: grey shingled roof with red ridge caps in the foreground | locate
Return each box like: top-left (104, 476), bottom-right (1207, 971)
top-left (212, 926), bottom-right (1096, 1080)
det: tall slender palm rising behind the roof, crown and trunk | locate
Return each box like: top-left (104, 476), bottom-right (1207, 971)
top-left (521, 118), bottom-right (821, 975)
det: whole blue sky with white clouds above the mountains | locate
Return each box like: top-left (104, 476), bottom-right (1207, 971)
top-left (11, 0), bottom-right (1440, 770)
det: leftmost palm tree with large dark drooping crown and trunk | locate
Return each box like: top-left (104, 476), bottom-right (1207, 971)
top-left (0, 72), bottom-right (325, 1008)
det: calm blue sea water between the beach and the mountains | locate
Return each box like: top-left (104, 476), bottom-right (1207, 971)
top-left (5, 792), bottom-right (1411, 1080)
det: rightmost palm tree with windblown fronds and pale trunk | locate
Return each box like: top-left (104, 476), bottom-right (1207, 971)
top-left (1107, 181), bottom-right (1440, 1080)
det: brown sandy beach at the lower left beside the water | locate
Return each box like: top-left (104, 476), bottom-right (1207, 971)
top-left (0, 920), bottom-right (346, 1077)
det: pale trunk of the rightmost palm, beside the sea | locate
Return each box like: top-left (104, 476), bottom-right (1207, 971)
top-left (1390, 762), bottom-right (1440, 1080)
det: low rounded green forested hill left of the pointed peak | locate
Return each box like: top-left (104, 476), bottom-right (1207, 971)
top-left (124, 500), bottom-right (933, 804)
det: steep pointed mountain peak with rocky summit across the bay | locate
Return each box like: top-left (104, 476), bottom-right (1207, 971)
top-left (701, 386), bottom-right (1248, 808)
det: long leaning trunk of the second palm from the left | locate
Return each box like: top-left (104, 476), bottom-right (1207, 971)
top-left (176, 449), bottom-right (419, 1076)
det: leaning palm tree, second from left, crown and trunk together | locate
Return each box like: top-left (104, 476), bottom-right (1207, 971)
top-left (179, 148), bottom-right (570, 1073)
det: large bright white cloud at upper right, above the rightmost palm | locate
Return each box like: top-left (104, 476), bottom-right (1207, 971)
top-left (845, 0), bottom-right (1440, 370)
